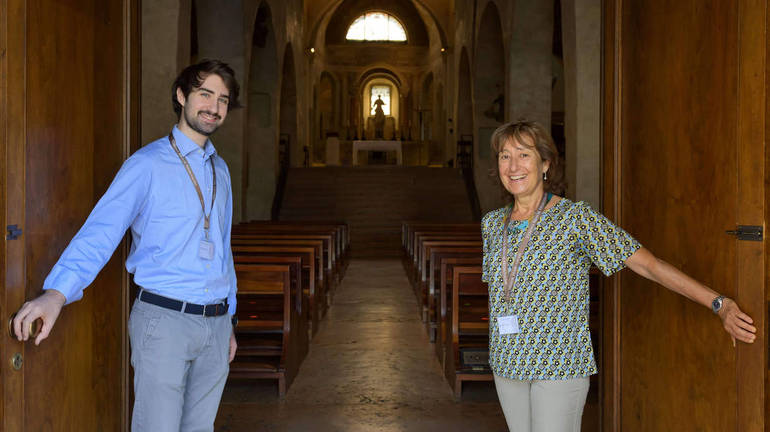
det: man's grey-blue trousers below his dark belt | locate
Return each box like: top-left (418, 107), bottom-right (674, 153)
top-left (128, 300), bottom-right (232, 432)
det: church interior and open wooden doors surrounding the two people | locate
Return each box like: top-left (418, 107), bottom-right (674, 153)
top-left (0, 0), bottom-right (770, 432)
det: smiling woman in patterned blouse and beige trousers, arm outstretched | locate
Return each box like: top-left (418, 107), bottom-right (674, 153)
top-left (481, 121), bottom-right (756, 432)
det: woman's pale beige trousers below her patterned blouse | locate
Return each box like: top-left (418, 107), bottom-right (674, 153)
top-left (494, 375), bottom-right (589, 432)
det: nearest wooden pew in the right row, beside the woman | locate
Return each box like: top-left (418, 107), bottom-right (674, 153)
top-left (444, 266), bottom-right (493, 399)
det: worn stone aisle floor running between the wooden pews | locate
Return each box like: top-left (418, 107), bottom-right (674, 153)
top-left (216, 259), bottom-right (507, 432)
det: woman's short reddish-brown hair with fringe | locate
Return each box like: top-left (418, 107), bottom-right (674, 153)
top-left (490, 120), bottom-right (567, 200)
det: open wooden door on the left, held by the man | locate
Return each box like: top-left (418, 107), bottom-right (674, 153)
top-left (0, 0), bottom-right (138, 432)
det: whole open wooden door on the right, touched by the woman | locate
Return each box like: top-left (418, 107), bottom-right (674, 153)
top-left (603, 0), bottom-right (768, 432)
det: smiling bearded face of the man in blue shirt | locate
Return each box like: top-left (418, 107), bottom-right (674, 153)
top-left (176, 74), bottom-right (230, 136)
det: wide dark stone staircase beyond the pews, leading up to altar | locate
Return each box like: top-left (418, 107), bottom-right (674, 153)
top-left (278, 166), bottom-right (473, 257)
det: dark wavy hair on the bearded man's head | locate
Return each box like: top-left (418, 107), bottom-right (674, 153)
top-left (171, 60), bottom-right (241, 116)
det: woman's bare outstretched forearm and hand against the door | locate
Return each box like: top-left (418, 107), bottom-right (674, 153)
top-left (626, 248), bottom-right (757, 343)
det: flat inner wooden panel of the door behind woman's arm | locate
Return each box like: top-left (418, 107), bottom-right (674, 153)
top-left (620, 1), bottom-right (738, 431)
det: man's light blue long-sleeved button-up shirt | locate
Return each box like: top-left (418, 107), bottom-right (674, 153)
top-left (43, 126), bottom-right (237, 314)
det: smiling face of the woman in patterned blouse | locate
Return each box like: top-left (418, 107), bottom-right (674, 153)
top-left (497, 138), bottom-right (550, 197)
